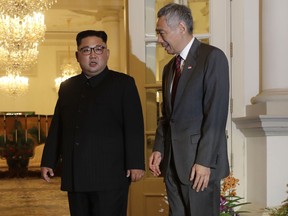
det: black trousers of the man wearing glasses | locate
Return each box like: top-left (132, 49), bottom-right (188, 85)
top-left (68, 188), bottom-right (128, 216)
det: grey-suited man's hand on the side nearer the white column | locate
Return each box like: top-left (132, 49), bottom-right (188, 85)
top-left (190, 164), bottom-right (211, 192)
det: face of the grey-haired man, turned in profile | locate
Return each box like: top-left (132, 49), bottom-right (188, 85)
top-left (156, 16), bottom-right (181, 55)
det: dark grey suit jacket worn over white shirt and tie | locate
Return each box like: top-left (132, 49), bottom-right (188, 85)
top-left (154, 38), bottom-right (229, 184)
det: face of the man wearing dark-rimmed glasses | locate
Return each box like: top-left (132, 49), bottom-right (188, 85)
top-left (76, 36), bottom-right (109, 77)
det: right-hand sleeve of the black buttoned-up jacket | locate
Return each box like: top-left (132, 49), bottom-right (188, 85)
top-left (123, 78), bottom-right (145, 170)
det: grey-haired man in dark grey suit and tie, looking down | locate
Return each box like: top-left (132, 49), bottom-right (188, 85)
top-left (149, 3), bottom-right (229, 216)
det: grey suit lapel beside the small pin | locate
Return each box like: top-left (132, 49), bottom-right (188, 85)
top-left (170, 38), bottom-right (201, 109)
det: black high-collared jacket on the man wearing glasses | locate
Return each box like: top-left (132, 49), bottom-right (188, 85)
top-left (41, 68), bottom-right (145, 192)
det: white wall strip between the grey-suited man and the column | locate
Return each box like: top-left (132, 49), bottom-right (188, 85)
top-left (231, 0), bottom-right (260, 202)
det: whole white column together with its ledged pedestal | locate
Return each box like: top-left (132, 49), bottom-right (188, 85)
top-left (233, 0), bottom-right (288, 216)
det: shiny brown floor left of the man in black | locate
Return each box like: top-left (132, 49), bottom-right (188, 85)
top-left (0, 177), bottom-right (70, 216)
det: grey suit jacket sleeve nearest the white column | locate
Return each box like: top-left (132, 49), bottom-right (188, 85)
top-left (196, 48), bottom-right (229, 168)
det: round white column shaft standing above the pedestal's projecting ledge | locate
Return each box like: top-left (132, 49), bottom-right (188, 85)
top-left (252, 0), bottom-right (288, 104)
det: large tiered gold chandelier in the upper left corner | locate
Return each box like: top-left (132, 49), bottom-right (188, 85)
top-left (0, 0), bottom-right (57, 96)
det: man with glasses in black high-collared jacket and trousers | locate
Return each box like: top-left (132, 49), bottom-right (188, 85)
top-left (41, 30), bottom-right (145, 216)
